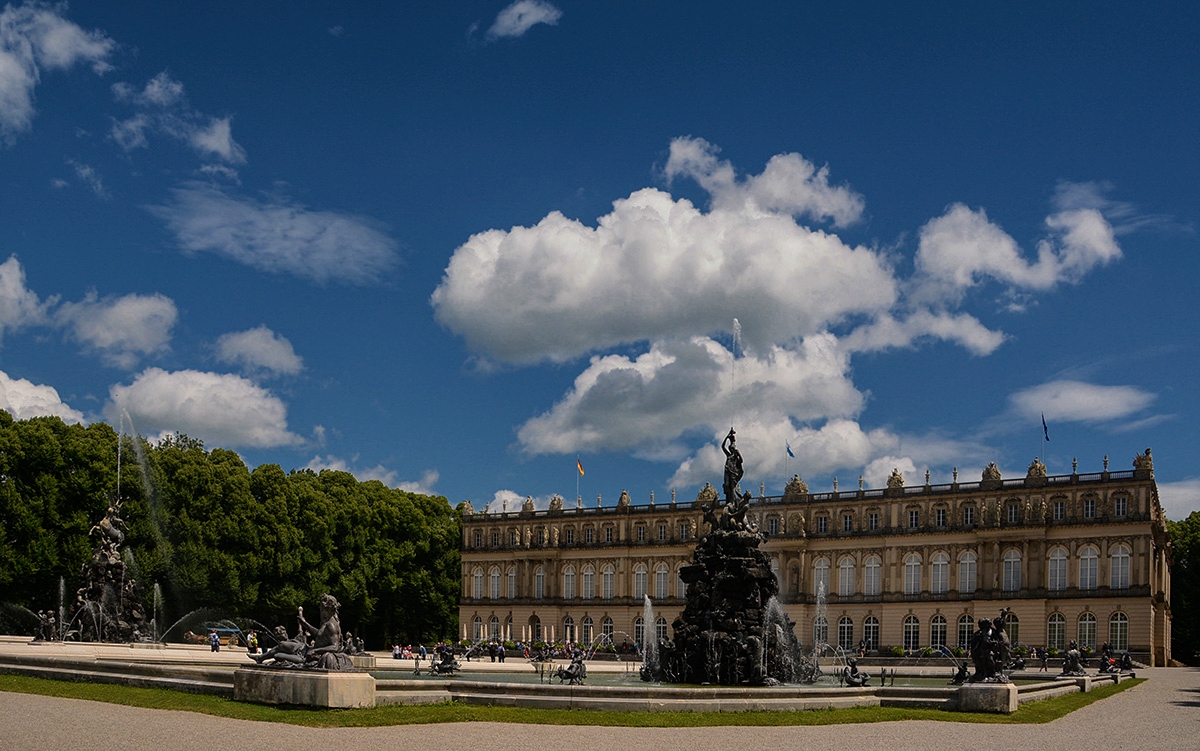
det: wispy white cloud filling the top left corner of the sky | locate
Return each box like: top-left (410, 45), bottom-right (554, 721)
top-left (0, 2), bottom-right (116, 145)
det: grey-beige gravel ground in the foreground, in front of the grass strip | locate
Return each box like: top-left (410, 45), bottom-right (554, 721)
top-left (0, 668), bottom-right (1200, 751)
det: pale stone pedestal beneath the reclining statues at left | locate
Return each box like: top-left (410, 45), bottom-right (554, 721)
top-left (233, 666), bottom-right (376, 709)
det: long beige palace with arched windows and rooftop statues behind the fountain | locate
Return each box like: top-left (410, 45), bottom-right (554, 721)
top-left (458, 449), bottom-right (1171, 666)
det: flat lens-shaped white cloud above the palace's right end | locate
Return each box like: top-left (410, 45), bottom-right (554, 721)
top-left (1008, 380), bottom-right (1156, 422)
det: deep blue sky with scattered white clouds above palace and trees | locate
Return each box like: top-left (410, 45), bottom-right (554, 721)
top-left (0, 0), bottom-right (1200, 518)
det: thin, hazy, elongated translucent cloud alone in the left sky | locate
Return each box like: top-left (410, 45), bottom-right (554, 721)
top-left (150, 182), bottom-right (397, 284)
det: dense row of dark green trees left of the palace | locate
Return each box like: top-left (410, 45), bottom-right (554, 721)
top-left (0, 410), bottom-right (461, 648)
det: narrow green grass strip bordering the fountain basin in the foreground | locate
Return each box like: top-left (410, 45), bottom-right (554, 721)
top-left (0, 674), bottom-right (1145, 727)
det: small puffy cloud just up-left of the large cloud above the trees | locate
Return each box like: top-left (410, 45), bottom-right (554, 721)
top-left (54, 292), bottom-right (179, 368)
